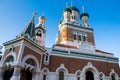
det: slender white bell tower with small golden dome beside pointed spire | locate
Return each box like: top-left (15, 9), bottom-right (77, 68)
top-left (35, 16), bottom-right (46, 46)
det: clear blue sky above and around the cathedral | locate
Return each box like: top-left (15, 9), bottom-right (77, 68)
top-left (0, 0), bottom-right (120, 63)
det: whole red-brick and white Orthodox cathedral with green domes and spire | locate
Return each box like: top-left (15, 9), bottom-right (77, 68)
top-left (0, 6), bottom-right (120, 80)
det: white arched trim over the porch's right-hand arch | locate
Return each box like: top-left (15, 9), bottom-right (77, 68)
top-left (22, 54), bottom-right (39, 71)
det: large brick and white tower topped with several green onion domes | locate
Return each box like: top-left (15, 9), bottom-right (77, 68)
top-left (56, 5), bottom-right (95, 52)
